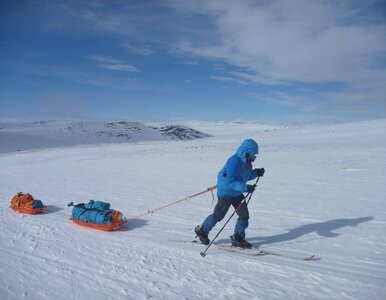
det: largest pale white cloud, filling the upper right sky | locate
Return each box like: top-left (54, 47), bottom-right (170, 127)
top-left (173, 0), bottom-right (386, 84)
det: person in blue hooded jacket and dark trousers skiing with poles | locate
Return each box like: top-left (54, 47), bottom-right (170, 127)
top-left (194, 139), bottom-right (265, 248)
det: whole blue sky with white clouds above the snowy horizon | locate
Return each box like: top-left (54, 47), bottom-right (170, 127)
top-left (0, 0), bottom-right (386, 123)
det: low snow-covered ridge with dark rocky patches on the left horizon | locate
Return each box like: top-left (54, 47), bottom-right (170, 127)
top-left (0, 121), bottom-right (211, 153)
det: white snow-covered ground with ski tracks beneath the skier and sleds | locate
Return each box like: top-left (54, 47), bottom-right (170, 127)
top-left (0, 120), bottom-right (386, 300)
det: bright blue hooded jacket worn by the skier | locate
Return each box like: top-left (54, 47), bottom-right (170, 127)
top-left (217, 139), bottom-right (259, 197)
